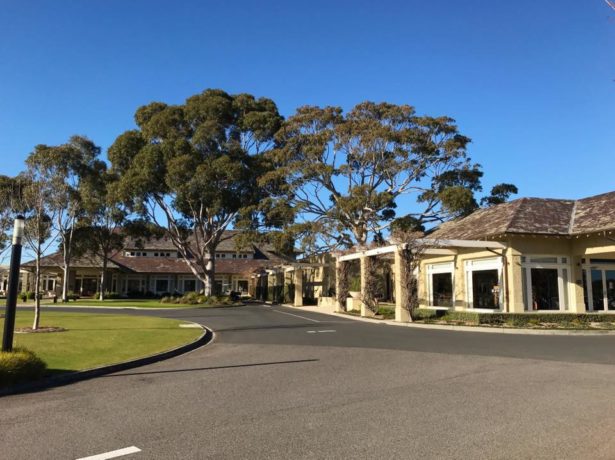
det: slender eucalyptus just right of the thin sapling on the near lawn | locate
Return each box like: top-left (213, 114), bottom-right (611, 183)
top-left (27, 136), bottom-right (100, 302)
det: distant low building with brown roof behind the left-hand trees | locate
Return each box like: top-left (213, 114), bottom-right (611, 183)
top-left (22, 231), bottom-right (291, 297)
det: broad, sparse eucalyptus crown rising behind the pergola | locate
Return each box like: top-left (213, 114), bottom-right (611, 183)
top-left (262, 102), bottom-right (516, 252)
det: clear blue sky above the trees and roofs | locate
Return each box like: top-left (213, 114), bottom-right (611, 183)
top-left (0, 0), bottom-right (615, 206)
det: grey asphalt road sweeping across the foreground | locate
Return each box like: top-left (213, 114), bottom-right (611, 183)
top-left (0, 305), bottom-right (615, 459)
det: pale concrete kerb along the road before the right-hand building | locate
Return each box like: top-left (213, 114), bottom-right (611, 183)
top-left (294, 307), bottom-right (615, 336)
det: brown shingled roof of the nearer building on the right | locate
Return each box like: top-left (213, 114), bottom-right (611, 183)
top-left (430, 192), bottom-right (615, 240)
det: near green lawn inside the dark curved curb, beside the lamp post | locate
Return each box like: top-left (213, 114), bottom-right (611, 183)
top-left (0, 308), bottom-right (203, 373)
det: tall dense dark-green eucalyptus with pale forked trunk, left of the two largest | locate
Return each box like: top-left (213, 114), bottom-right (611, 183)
top-left (109, 89), bottom-right (282, 295)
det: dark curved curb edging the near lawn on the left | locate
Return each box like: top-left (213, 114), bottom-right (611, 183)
top-left (0, 321), bottom-right (215, 397)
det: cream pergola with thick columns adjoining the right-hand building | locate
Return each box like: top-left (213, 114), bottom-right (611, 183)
top-left (334, 238), bottom-right (507, 322)
